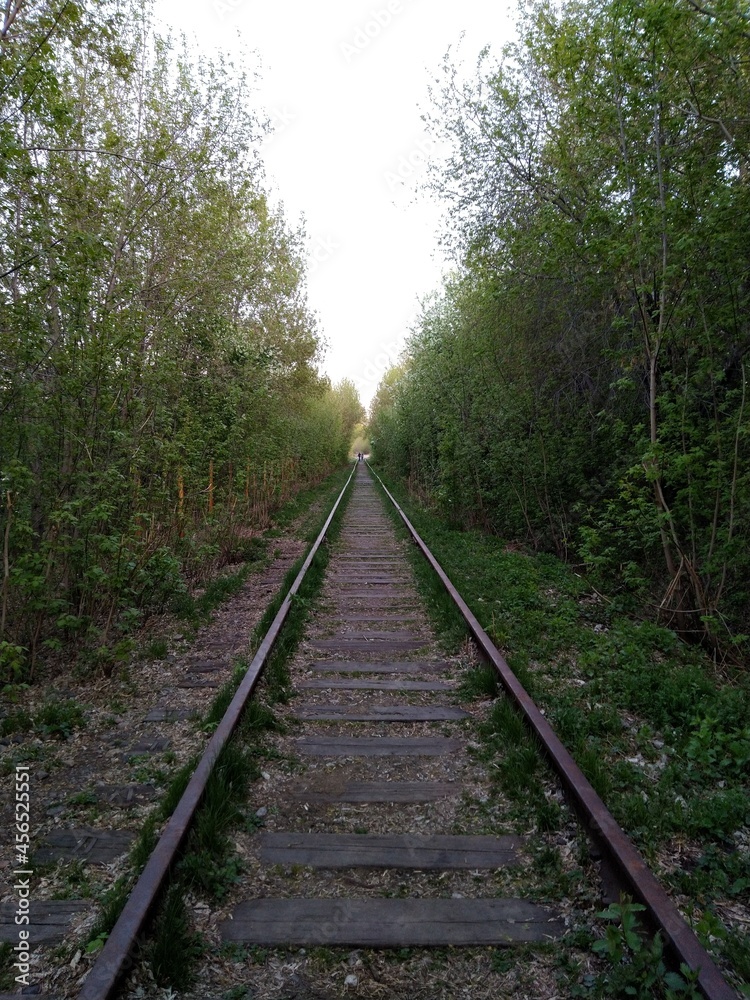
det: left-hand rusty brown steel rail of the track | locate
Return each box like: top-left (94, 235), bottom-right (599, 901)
top-left (78, 464), bottom-right (357, 1000)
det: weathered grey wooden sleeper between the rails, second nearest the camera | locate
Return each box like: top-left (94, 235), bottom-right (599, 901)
top-left (260, 833), bottom-right (522, 870)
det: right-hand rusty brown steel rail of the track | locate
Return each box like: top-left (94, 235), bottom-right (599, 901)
top-left (367, 462), bottom-right (737, 1000)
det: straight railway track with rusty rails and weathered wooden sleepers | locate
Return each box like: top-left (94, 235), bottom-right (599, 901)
top-left (8, 464), bottom-right (737, 1000)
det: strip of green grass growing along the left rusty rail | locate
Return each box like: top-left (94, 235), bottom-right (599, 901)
top-left (136, 464), bottom-right (358, 989)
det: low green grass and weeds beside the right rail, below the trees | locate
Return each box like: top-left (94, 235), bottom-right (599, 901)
top-left (368, 464), bottom-right (750, 996)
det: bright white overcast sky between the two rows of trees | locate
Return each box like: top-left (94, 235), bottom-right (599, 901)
top-left (153, 0), bottom-right (513, 405)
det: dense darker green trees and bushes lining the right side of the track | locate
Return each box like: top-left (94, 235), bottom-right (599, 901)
top-left (372, 0), bottom-right (750, 651)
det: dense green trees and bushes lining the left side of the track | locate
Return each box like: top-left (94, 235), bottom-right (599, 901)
top-left (0, 0), bottom-right (361, 682)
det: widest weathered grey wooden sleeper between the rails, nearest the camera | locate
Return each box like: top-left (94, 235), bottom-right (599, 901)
top-left (220, 899), bottom-right (565, 948)
